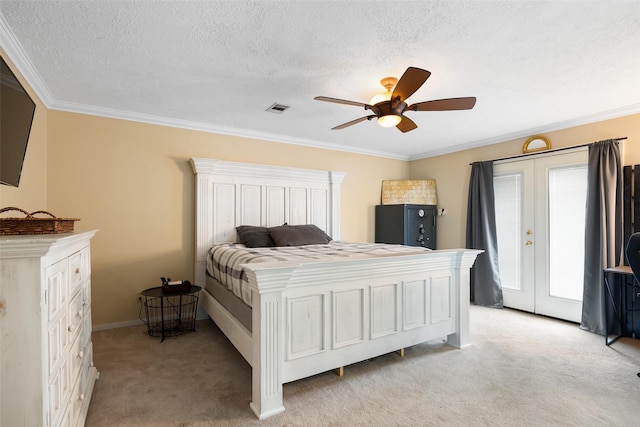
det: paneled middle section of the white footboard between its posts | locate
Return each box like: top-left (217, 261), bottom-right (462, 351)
top-left (282, 272), bottom-right (455, 382)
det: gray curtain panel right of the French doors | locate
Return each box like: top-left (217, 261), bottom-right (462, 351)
top-left (580, 139), bottom-right (623, 335)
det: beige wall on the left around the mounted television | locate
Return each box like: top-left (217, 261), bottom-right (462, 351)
top-left (0, 49), bottom-right (48, 210)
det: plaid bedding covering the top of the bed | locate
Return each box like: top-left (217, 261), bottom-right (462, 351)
top-left (207, 241), bottom-right (430, 306)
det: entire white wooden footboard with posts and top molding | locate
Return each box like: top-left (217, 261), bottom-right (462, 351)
top-left (245, 249), bottom-right (481, 418)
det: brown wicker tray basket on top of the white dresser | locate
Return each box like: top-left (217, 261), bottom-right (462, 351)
top-left (0, 207), bottom-right (80, 236)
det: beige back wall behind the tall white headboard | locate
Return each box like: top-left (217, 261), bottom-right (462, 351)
top-left (48, 111), bottom-right (408, 325)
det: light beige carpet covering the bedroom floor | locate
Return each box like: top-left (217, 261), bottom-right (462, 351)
top-left (86, 306), bottom-right (640, 427)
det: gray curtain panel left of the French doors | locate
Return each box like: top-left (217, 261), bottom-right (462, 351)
top-left (467, 160), bottom-right (503, 308)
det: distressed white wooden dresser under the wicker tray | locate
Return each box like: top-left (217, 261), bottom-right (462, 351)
top-left (0, 231), bottom-right (98, 427)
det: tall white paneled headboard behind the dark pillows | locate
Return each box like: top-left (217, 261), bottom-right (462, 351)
top-left (191, 158), bottom-right (345, 285)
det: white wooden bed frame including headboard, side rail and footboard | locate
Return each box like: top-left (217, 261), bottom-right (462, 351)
top-left (191, 158), bottom-right (482, 419)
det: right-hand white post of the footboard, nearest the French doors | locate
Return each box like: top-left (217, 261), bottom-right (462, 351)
top-left (447, 249), bottom-right (484, 348)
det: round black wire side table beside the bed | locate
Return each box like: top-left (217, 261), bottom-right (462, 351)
top-left (141, 285), bottom-right (202, 342)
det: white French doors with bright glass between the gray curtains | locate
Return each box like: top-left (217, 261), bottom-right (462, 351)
top-left (493, 149), bottom-right (588, 322)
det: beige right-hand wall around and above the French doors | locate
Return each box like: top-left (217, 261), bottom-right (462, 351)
top-left (409, 114), bottom-right (640, 249)
